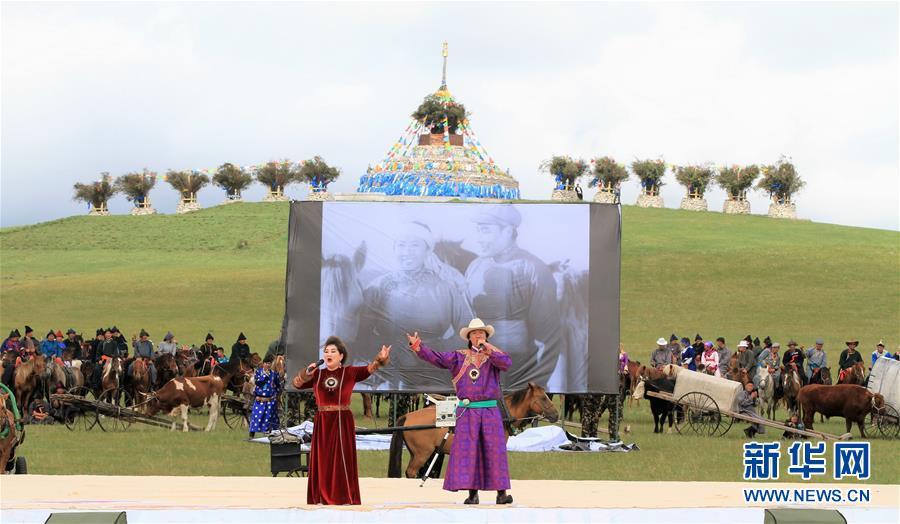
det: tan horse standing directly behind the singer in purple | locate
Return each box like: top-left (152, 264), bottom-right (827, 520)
top-left (388, 382), bottom-right (559, 478)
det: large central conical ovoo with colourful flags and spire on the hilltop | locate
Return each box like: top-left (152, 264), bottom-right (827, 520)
top-left (357, 43), bottom-right (519, 200)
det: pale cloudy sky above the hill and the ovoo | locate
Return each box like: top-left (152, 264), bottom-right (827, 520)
top-left (0, 2), bottom-right (900, 230)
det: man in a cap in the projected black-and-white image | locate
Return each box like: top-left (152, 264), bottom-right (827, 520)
top-left (466, 204), bottom-right (564, 389)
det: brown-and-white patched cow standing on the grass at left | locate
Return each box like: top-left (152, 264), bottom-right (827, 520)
top-left (147, 375), bottom-right (227, 432)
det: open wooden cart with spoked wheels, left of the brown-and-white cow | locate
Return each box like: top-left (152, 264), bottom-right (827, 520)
top-left (50, 391), bottom-right (202, 431)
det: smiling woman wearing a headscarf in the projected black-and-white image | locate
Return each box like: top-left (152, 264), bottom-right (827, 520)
top-left (362, 221), bottom-right (474, 386)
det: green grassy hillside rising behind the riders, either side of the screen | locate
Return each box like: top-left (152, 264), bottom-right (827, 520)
top-left (0, 203), bottom-right (900, 358)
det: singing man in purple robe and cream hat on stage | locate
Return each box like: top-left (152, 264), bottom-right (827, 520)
top-left (407, 318), bottom-right (512, 504)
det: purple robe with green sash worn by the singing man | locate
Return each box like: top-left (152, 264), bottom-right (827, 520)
top-left (416, 345), bottom-right (512, 491)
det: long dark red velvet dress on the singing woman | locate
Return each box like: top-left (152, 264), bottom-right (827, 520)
top-left (300, 366), bottom-right (369, 505)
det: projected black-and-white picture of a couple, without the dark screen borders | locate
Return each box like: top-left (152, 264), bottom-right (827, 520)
top-left (319, 203), bottom-right (590, 391)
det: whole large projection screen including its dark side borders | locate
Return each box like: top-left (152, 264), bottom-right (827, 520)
top-left (283, 202), bottom-right (621, 393)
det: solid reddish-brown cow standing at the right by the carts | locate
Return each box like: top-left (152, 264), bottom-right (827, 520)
top-left (797, 384), bottom-right (884, 438)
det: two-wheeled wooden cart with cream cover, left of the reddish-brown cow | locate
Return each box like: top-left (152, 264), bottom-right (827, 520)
top-left (647, 367), bottom-right (850, 440)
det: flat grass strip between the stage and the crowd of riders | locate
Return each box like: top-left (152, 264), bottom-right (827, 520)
top-left (19, 396), bottom-right (900, 484)
